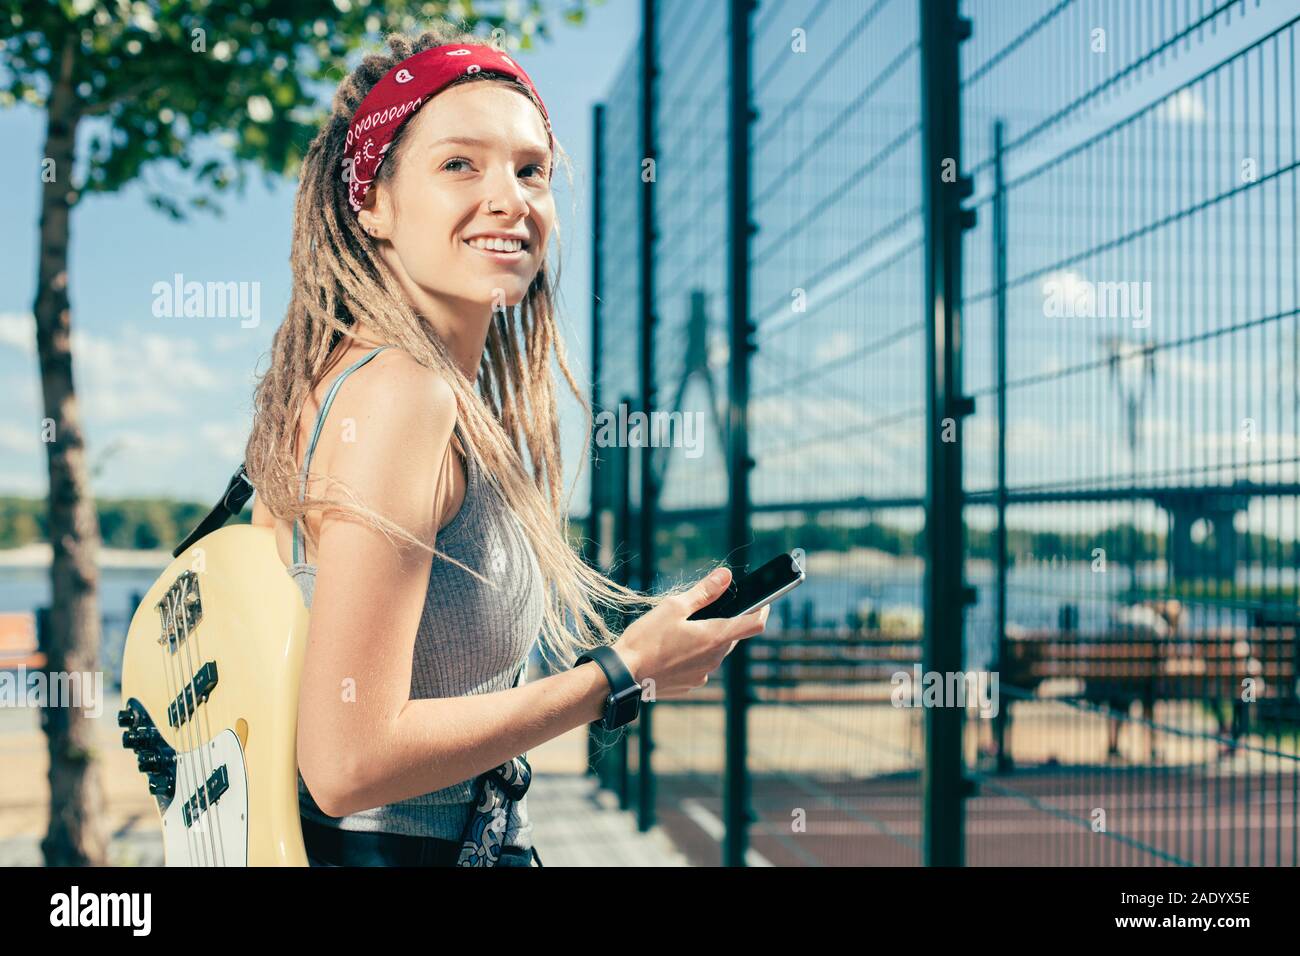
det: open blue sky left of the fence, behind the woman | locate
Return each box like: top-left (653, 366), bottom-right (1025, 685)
top-left (0, 0), bottom-right (640, 512)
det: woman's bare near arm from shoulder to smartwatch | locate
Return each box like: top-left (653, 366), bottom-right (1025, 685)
top-left (298, 350), bottom-right (608, 817)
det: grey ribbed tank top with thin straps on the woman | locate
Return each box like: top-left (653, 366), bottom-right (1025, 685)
top-left (287, 346), bottom-right (545, 849)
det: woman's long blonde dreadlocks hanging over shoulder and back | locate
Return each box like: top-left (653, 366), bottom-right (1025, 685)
top-left (244, 21), bottom-right (688, 665)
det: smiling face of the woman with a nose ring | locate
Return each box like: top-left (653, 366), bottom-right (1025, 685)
top-left (361, 82), bottom-right (555, 310)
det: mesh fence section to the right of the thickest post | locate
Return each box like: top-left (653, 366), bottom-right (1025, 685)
top-left (962, 3), bottom-right (1300, 865)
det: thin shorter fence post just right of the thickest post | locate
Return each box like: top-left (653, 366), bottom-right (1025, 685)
top-left (993, 120), bottom-right (1011, 774)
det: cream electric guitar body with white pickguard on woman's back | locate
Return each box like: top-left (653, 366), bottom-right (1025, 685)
top-left (118, 524), bottom-right (308, 866)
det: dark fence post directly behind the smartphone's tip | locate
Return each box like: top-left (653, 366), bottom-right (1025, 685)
top-left (722, 0), bottom-right (758, 866)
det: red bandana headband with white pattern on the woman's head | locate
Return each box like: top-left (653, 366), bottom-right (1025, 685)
top-left (343, 43), bottom-right (555, 212)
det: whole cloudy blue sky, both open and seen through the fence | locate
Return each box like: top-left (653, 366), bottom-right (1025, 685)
top-left (0, 0), bottom-right (1300, 554)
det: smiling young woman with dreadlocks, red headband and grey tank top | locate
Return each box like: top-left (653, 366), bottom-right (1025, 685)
top-left (246, 23), bottom-right (767, 866)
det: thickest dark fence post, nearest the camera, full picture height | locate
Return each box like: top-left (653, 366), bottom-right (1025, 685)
top-left (920, 0), bottom-right (974, 866)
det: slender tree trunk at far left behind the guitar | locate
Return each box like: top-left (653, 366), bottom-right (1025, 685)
top-left (34, 31), bottom-right (112, 866)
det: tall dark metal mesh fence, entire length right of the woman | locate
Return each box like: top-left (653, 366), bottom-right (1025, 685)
top-left (589, 0), bottom-right (1300, 865)
